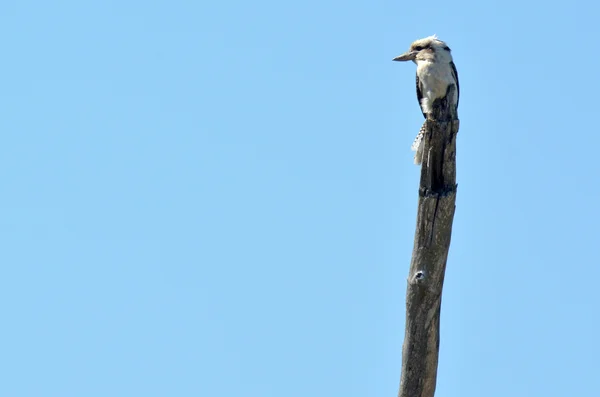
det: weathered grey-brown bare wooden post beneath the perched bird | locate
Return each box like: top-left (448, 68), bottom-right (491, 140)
top-left (398, 85), bottom-right (459, 397)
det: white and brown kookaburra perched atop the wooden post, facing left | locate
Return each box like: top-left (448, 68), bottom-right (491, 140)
top-left (394, 35), bottom-right (460, 164)
